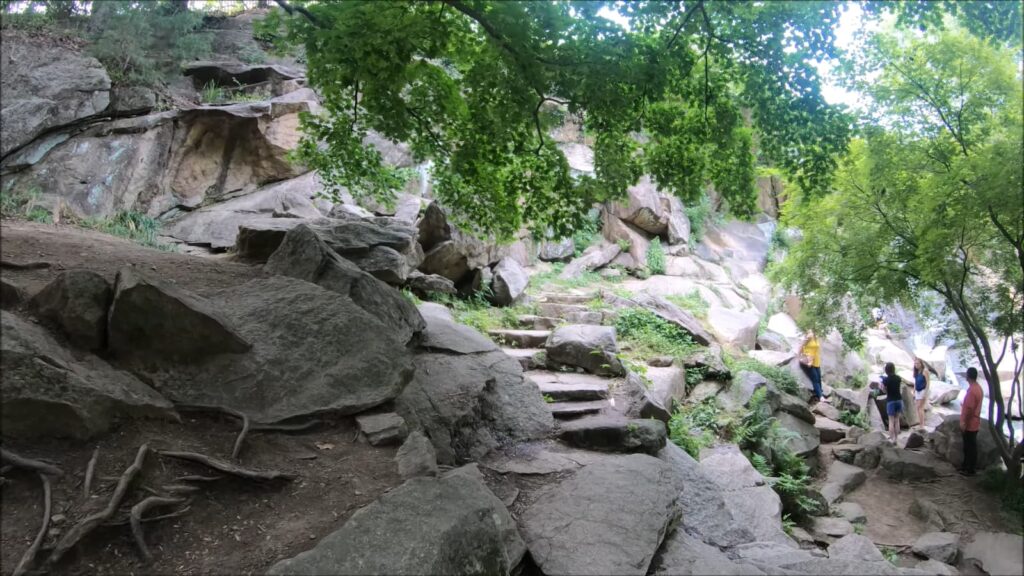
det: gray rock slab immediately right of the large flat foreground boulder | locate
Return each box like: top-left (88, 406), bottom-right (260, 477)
top-left (657, 443), bottom-right (757, 545)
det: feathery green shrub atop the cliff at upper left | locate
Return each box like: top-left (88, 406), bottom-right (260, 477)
top-left (89, 2), bottom-right (212, 86)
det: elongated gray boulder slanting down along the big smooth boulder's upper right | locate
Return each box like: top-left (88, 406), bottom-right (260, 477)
top-left (263, 224), bottom-right (426, 343)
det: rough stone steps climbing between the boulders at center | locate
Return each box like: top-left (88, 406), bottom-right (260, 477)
top-left (488, 293), bottom-right (616, 420)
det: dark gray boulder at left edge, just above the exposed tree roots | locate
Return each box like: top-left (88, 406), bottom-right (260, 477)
top-left (0, 312), bottom-right (177, 440)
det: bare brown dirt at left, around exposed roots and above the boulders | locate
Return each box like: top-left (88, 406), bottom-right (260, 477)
top-left (0, 221), bottom-right (400, 575)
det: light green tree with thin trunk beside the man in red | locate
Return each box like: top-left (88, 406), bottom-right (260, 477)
top-left (775, 20), bottom-right (1024, 478)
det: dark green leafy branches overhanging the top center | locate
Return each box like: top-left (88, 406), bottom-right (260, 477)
top-left (260, 0), bottom-right (849, 238)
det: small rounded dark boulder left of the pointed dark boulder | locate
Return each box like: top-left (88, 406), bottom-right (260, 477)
top-left (30, 271), bottom-right (114, 351)
